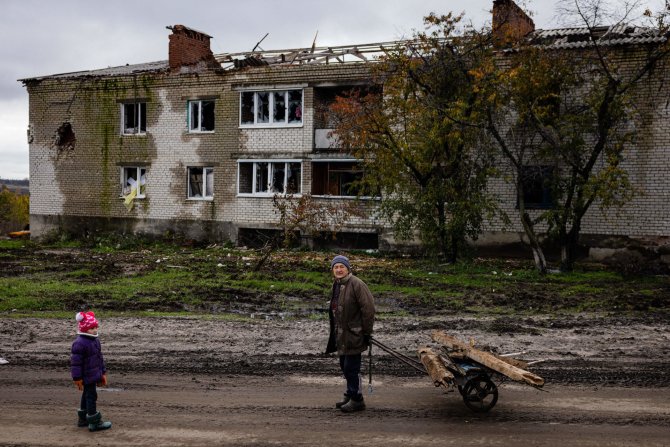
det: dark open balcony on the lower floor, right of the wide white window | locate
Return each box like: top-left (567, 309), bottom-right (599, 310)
top-left (312, 161), bottom-right (372, 197)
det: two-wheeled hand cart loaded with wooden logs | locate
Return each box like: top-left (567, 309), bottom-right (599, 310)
top-left (370, 331), bottom-right (544, 413)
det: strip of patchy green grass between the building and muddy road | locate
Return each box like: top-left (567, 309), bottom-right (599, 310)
top-left (0, 237), bottom-right (670, 321)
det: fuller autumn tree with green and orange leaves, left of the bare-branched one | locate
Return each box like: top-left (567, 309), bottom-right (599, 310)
top-left (331, 14), bottom-right (496, 262)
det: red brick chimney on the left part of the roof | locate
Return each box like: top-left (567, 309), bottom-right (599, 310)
top-left (167, 25), bottom-right (221, 70)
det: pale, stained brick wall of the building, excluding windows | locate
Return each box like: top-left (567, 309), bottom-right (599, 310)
top-left (29, 59), bottom-right (670, 245)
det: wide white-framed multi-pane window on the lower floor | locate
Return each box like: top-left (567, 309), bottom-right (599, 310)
top-left (237, 160), bottom-right (302, 195)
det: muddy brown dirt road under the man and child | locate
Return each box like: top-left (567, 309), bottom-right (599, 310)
top-left (0, 315), bottom-right (670, 447)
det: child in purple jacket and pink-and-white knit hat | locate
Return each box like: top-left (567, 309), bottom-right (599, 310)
top-left (70, 312), bottom-right (112, 431)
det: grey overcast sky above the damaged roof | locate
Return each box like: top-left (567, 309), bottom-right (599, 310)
top-left (0, 0), bottom-right (662, 179)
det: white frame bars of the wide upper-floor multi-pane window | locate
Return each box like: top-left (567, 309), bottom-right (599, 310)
top-left (239, 87), bottom-right (305, 129)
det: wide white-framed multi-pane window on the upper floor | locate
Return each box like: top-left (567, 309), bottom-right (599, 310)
top-left (240, 90), bottom-right (302, 126)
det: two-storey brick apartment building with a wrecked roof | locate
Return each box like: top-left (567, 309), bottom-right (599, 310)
top-left (21, 0), bottom-right (670, 258)
